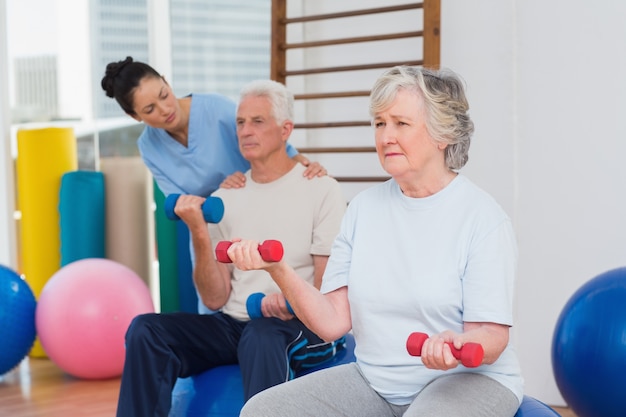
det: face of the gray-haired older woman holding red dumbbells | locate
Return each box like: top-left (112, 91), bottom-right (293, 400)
top-left (374, 90), bottom-right (445, 180)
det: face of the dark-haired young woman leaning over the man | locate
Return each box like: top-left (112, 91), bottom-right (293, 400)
top-left (133, 77), bottom-right (182, 130)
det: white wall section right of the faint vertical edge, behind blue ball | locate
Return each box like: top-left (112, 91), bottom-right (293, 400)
top-left (516, 0), bottom-right (626, 401)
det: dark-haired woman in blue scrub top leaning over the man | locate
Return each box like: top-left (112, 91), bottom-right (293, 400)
top-left (101, 57), bottom-right (326, 313)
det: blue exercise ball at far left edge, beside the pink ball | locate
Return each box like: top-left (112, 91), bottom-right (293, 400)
top-left (0, 265), bottom-right (37, 375)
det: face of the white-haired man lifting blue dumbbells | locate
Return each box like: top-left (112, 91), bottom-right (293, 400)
top-left (237, 96), bottom-right (286, 161)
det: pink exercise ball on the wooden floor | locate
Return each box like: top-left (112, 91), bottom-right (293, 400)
top-left (35, 258), bottom-right (154, 379)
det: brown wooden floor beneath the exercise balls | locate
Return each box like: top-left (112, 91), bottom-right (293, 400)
top-left (0, 358), bottom-right (576, 417)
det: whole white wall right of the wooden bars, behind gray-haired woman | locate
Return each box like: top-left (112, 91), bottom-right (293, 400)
top-left (442, 0), bottom-right (626, 405)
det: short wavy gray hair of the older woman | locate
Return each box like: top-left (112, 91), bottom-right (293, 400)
top-left (370, 66), bottom-right (474, 169)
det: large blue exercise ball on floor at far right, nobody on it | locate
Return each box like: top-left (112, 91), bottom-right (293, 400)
top-left (552, 267), bottom-right (626, 417)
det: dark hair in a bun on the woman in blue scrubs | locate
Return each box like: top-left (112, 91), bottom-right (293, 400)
top-left (100, 56), bottom-right (161, 116)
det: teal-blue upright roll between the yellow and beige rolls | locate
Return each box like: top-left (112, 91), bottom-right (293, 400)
top-left (59, 171), bottom-right (106, 266)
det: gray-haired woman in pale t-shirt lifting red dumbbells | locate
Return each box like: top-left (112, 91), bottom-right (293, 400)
top-left (229, 66), bottom-right (523, 417)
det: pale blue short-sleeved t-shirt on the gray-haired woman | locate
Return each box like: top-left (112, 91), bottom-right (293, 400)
top-left (321, 175), bottom-right (523, 404)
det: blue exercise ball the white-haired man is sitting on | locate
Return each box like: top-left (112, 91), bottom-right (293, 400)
top-left (169, 334), bottom-right (355, 417)
